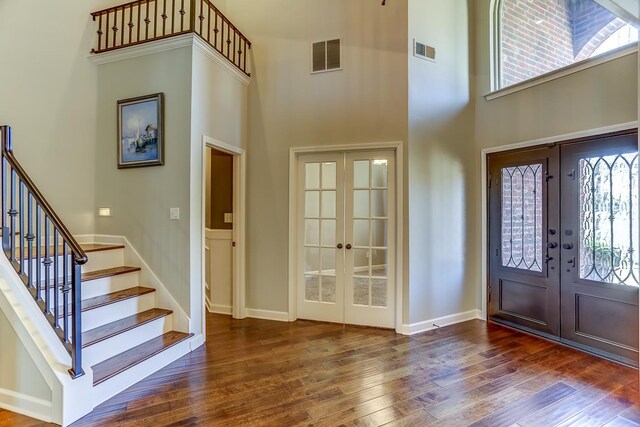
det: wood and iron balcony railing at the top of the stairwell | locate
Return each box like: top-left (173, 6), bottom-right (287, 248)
top-left (91, 0), bottom-right (251, 76)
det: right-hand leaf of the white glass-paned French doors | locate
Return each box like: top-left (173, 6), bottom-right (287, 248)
top-left (344, 152), bottom-right (396, 328)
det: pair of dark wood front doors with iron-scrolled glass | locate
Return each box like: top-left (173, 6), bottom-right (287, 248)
top-left (488, 134), bottom-right (640, 366)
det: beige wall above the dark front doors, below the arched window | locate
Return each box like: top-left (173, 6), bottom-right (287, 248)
top-left (470, 0), bottom-right (638, 306)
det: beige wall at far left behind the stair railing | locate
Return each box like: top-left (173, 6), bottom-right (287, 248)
top-left (0, 0), bottom-right (122, 234)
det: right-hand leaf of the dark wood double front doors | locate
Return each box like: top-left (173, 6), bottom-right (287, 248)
top-left (560, 135), bottom-right (640, 365)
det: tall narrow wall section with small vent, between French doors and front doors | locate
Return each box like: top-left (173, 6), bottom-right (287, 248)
top-left (408, 0), bottom-right (476, 323)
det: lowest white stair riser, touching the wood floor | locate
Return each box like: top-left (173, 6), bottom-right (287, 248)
top-left (93, 339), bottom-right (191, 406)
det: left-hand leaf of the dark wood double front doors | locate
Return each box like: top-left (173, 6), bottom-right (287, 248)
top-left (489, 147), bottom-right (560, 339)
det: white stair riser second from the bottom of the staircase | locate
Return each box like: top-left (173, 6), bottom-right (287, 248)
top-left (83, 315), bottom-right (172, 366)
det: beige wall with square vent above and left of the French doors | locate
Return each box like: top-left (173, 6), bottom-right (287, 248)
top-left (227, 0), bottom-right (407, 311)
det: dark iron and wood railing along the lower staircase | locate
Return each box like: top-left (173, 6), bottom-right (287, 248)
top-left (0, 126), bottom-right (87, 378)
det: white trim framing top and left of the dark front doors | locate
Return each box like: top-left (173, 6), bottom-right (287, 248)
top-left (478, 121), bottom-right (638, 319)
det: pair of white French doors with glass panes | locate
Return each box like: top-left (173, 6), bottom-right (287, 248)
top-left (297, 151), bottom-right (396, 328)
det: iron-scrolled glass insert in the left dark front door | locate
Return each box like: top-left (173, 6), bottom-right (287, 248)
top-left (501, 163), bottom-right (543, 272)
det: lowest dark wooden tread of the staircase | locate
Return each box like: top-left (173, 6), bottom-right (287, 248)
top-left (92, 331), bottom-right (193, 386)
